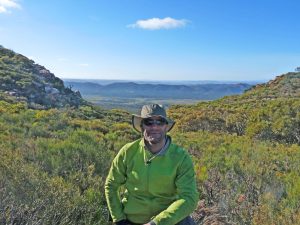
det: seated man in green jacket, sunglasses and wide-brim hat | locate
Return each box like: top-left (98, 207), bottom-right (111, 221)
top-left (105, 104), bottom-right (198, 225)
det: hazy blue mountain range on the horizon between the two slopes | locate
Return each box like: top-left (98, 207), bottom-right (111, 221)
top-left (65, 81), bottom-right (252, 100)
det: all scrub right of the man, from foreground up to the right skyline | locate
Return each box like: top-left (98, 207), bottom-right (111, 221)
top-left (169, 73), bottom-right (300, 225)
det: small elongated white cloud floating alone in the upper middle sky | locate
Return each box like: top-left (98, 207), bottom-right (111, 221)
top-left (128, 17), bottom-right (187, 30)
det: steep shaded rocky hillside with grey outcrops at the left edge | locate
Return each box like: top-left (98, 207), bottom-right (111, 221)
top-left (0, 45), bottom-right (84, 109)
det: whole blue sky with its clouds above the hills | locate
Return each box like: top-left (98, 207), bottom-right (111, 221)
top-left (0, 0), bottom-right (300, 81)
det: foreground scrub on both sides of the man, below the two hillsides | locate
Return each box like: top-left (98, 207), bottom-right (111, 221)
top-left (0, 102), bottom-right (300, 225)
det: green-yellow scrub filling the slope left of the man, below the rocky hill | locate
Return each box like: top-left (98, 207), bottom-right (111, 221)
top-left (0, 101), bottom-right (137, 225)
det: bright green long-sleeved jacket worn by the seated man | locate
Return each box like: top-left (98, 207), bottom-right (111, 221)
top-left (105, 138), bottom-right (198, 225)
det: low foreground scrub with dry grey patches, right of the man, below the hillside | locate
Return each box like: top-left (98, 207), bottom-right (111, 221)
top-left (174, 132), bottom-right (300, 225)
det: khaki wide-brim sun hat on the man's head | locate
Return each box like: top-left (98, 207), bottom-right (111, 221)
top-left (132, 104), bottom-right (175, 132)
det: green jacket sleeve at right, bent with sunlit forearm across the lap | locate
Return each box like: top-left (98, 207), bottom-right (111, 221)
top-left (152, 155), bottom-right (199, 225)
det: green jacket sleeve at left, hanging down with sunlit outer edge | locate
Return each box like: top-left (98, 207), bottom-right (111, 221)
top-left (105, 147), bottom-right (126, 222)
